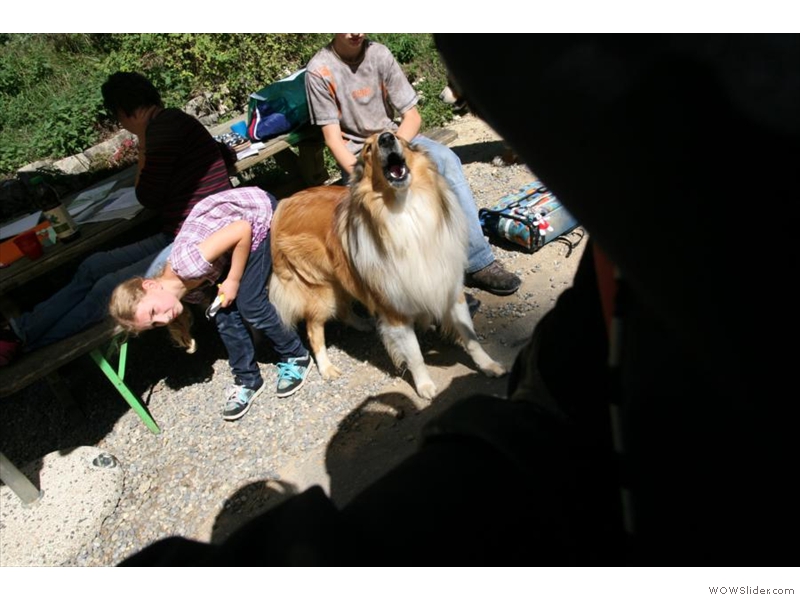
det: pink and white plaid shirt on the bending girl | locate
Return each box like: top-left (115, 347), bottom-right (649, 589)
top-left (169, 187), bottom-right (272, 283)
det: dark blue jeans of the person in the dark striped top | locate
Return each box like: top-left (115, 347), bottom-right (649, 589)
top-left (11, 233), bottom-right (173, 351)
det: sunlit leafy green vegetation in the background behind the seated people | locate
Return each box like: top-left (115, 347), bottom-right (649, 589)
top-left (0, 33), bottom-right (452, 178)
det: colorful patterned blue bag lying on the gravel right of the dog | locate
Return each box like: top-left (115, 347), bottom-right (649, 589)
top-left (478, 179), bottom-right (580, 253)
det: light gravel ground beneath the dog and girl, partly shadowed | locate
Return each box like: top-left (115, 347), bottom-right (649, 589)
top-left (0, 116), bottom-right (585, 566)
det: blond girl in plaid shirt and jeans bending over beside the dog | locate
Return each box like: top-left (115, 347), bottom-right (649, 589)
top-left (109, 187), bottom-right (311, 421)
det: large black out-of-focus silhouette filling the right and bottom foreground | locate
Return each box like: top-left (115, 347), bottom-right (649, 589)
top-left (117, 35), bottom-right (800, 566)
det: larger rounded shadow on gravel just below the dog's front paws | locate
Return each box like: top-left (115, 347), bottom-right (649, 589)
top-left (325, 370), bottom-right (505, 507)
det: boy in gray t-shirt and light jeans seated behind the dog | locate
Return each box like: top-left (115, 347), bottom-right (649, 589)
top-left (306, 33), bottom-right (521, 296)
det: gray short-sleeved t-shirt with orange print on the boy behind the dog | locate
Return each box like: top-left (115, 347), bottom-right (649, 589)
top-left (306, 40), bottom-right (419, 154)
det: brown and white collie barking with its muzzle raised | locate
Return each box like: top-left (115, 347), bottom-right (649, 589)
top-left (269, 132), bottom-right (505, 399)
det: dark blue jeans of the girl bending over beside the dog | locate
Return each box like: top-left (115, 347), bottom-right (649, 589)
top-left (215, 234), bottom-right (308, 389)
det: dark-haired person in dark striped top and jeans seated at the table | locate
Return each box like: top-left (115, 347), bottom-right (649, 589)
top-left (0, 72), bottom-right (232, 366)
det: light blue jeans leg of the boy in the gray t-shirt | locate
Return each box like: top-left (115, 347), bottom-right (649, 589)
top-left (412, 135), bottom-right (494, 273)
